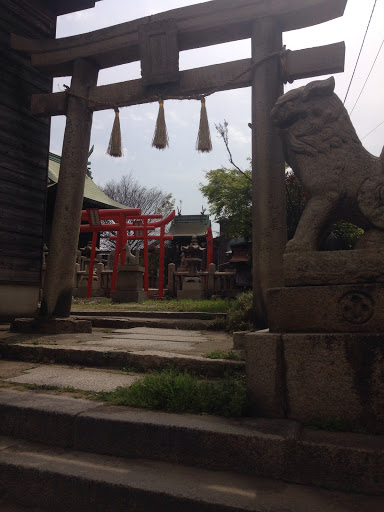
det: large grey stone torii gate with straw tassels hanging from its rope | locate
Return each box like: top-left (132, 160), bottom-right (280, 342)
top-left (12, 0), bottom-right (347, 325)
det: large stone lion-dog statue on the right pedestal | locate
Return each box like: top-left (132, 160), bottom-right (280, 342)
top-left (271, 77), bottom-right (384, 251)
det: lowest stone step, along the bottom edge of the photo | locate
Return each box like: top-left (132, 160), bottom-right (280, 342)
top-left (0, 438), bottom-right (383, 512)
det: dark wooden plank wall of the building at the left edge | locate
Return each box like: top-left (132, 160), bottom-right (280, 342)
top-left (0, 0), bottom-right (56, 285)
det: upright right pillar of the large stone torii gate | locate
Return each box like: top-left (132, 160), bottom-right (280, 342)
top-left (252, 18), bottom-right (287, 327)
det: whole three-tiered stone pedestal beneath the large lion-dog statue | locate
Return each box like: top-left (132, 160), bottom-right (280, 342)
top-left (245, 250), bottom-right (384, 434)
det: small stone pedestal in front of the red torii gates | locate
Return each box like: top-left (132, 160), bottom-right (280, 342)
top-left (112, 265), bottom-right (147, 302)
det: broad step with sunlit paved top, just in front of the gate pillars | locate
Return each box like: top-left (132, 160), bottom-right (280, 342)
top-left (0, 327), bottom-right (245, 377)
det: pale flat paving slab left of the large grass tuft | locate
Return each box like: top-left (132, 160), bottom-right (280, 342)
top-left (2, 362), bottom-right (140, 391)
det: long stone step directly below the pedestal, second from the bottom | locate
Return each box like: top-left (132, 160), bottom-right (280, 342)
top-left (0, 390), bottom-right (384, 494)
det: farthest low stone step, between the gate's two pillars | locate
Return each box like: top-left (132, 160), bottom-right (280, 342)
top-left (71, 313), bottom-right (214, 331)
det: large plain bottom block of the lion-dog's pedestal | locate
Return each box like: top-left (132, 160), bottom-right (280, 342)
top-left (245, 333), bottom-right (384, 434)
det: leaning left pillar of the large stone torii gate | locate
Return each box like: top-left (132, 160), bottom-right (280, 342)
top-left (40, 59), bottom-right (98, 318)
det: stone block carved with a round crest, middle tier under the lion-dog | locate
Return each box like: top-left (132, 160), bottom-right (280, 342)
top-left (268, 283), bottom-right (384, 333)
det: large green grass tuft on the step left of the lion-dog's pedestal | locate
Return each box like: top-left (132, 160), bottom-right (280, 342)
top-left (100, 368), bottom-right (246, 417)
